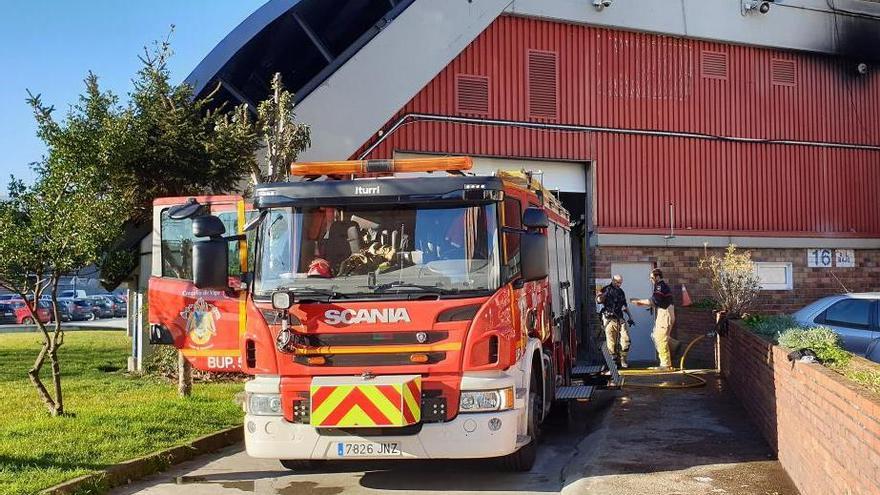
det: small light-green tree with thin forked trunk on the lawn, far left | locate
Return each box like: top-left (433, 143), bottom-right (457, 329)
top-left (0, 127), bottom-right (123, 416)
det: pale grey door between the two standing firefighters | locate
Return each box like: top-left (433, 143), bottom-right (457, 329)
top-left (611, 263), bottom-right (657, 362)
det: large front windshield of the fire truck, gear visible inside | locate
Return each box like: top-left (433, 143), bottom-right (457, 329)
top-left (254, 204), bottom-right (500, 297)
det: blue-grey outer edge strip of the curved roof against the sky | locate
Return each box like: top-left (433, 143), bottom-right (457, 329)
top-left (184, 0), bottom-right (300, 94)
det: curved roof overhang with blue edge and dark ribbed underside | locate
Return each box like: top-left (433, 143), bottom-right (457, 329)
top-left (185, 0), bottom-right (414, 109)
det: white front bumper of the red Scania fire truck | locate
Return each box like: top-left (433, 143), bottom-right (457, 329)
top-left (244, 409), bottom-right (520, 460)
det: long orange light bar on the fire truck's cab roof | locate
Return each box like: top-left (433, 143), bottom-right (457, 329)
top-left (290, 156), bottom-right (473, 176)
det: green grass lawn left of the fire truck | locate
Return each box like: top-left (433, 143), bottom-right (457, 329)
top-left (0, 331), bottom-right (244, 495)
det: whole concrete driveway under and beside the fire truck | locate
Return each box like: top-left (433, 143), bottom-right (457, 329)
top-left (112, 377), bottom-right (797, 495)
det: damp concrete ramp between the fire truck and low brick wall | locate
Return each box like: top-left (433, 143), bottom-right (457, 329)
top-left (564, 376), bottom-right (798, 495)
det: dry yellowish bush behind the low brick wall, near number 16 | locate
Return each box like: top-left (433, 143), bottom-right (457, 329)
top-left (700, 244), bottom-right (761, 318)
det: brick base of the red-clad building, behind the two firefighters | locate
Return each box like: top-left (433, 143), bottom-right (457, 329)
top-left (588, 246), bottom-right (880, 313)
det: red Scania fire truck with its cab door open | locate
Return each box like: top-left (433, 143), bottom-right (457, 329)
top-left (149, 157), bottom-right (585, 470)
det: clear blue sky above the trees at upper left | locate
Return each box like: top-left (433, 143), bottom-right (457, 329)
top-left (0, 0), bottom-right (265, 185)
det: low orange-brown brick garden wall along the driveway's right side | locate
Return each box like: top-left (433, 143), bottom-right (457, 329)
top-left (721, 324), bottom-right (880, 495)
